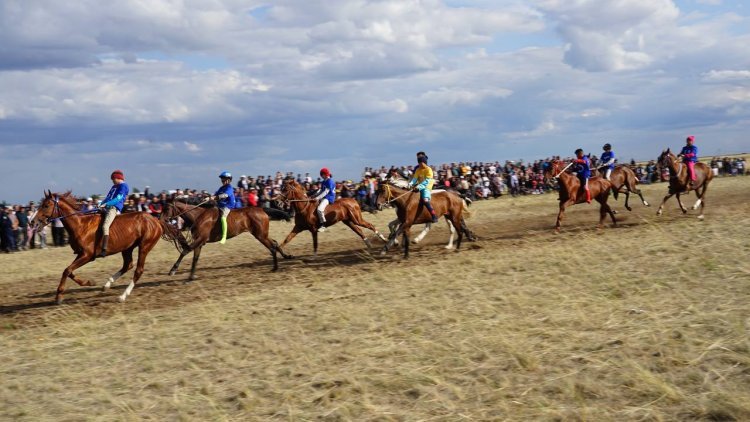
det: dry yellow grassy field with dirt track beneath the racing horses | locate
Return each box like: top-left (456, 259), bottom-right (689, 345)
top-left (0, 177), bottom-right (750, 421)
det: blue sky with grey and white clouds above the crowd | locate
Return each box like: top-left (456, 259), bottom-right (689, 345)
top-left (0, 0), bottom-right (750, 202)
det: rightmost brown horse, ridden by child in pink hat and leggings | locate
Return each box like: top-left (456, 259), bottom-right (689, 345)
top-left (656, 149), bottom-right (714, 220)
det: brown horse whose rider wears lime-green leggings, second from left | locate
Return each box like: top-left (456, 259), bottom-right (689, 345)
top-left (159, 200), bottom-right (291, 281)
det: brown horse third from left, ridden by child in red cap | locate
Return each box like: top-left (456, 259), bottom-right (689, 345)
top-left (276, 179), bottom-right (387, 257)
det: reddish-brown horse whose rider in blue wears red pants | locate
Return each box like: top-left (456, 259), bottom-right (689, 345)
top-left (544, 160), bottom-right (617, 232)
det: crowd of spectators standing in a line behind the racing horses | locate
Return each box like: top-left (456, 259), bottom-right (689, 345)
top-left (0, 156), bottom-right (747, 252)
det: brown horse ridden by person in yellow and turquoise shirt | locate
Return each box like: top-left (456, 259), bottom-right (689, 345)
top-left (377, 182), bottom-right (471, 258)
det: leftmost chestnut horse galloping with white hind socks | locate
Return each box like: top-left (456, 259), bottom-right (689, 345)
top-left (32, 191), bottom-right (168, 304)
